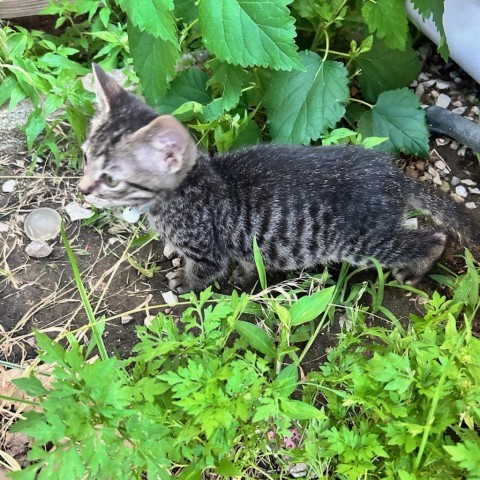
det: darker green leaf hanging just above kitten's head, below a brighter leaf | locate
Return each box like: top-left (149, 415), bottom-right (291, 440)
top-left (127, 22), bottom-right (179, 106)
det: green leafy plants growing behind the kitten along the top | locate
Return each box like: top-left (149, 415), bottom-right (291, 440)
top-left (0, 0), bottom-right (447, 166)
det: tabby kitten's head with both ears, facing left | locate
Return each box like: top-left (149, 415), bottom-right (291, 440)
top-left (79, 65), bottom-right (197, 206)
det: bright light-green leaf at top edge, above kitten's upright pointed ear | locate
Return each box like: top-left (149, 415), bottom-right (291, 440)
top-left (117, 0), bottom-right (178, 48)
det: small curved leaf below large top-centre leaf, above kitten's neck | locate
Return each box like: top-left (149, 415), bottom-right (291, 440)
top-left (203, 59), bottom-right (244, 122)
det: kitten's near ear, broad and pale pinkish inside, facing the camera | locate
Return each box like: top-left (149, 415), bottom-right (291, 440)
top-left (130, 115), bottom-right (197, 173)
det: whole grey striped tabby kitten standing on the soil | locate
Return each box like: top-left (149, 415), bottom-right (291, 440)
top-left (79, 65), bottom-right (472, 292)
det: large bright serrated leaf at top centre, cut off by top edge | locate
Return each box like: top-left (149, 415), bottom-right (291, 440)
top-left (198, 0), bottom-right (302, 71)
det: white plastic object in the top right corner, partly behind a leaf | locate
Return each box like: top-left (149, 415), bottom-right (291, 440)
top-left (406, 0), bottom-right (480, 83)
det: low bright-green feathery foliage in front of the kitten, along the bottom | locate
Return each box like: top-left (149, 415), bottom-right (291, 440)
top-left (11, 252), bottom-right (480, 480)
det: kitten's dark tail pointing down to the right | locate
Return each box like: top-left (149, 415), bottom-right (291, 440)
top-left (407, 183), bottom-right (474, 244)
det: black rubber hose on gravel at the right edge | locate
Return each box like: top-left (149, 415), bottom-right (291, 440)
top-left (426, 107), bottom-right (480, 152)
